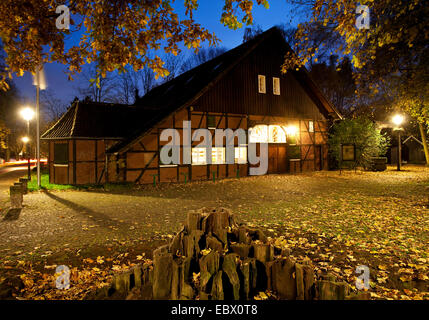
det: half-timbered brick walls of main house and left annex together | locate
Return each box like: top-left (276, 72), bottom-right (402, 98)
top-left (48, 108), bottom-right (328, 185)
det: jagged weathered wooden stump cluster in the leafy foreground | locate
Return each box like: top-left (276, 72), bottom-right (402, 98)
top-left (92, 208), bottom-right (367, 300)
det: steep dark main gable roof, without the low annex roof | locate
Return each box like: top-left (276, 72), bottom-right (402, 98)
top-left (108, 27), bottom-right (341, 153)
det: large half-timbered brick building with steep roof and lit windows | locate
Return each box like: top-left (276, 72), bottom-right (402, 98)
top-left (42, 28), bottom-right (341, 184)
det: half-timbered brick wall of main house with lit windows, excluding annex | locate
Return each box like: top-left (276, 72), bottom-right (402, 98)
top-left (106, 107), bottom-right (328, 184)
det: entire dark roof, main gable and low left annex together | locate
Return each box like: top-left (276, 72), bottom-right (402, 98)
top-left (42, 27), bottom-right (341, 153)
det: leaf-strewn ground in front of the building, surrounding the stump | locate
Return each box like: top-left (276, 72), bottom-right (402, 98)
top-left (0, 166), bottom-right (429, 299)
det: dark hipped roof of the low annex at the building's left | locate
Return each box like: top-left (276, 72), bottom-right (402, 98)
top-left (42, 101), bottom-right (155, 139)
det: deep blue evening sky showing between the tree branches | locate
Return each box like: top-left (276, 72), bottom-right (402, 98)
top-left (14, 0), bottom-right (300, 103)
